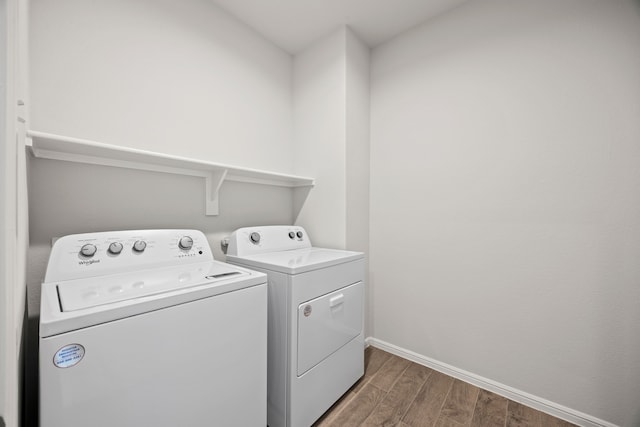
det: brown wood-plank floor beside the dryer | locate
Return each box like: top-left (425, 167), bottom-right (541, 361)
top-left (313, 347), bottom-right (573, 427)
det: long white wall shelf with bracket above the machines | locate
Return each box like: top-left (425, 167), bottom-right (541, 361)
top-left (26, 130), bottom-right (314, 215)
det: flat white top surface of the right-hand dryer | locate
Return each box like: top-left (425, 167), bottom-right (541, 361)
top-left (227, 248), bottom-right (364, 274)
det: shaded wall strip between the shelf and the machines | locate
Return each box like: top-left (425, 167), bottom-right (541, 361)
top-left (29, 158), bottom-right (293, 268)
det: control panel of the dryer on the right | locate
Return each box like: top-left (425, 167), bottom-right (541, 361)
top-left (227, 225), bottom-right (311, 256)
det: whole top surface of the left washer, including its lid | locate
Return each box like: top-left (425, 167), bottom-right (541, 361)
top-left (40, 261), bottom-right (267, 338)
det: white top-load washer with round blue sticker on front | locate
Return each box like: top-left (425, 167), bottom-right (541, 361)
top-left (39, 230), bottom-right (267, 427)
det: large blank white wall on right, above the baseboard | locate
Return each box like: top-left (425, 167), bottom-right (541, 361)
top-left (371, 0), bottom-right (640, 426)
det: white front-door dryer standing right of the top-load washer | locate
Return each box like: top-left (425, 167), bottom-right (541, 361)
top-left (227, 226), bottom-right (365, 427)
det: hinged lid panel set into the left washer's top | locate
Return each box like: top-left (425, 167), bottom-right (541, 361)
top-left (57, 262), bottom-right (249, 312)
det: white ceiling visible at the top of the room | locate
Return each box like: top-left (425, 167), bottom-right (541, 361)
top-left (212, 0), bottom-right (468, 54)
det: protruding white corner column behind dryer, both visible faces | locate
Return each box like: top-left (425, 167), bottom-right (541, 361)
top-left (293, 27), bottom-right (369, 251)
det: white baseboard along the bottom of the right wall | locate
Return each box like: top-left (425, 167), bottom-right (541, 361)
top-left (366, 337), bottom-right (618, 427)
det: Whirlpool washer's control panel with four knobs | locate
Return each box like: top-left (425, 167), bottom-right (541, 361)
top-left (45, 229), bottom-right (213, 282)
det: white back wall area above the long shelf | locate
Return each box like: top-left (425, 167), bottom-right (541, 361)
top-left (30, 0), bottom-right (293, 173)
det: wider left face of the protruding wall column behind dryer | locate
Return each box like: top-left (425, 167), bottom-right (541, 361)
top-left (293, 28), bottom-right (347, 249)
